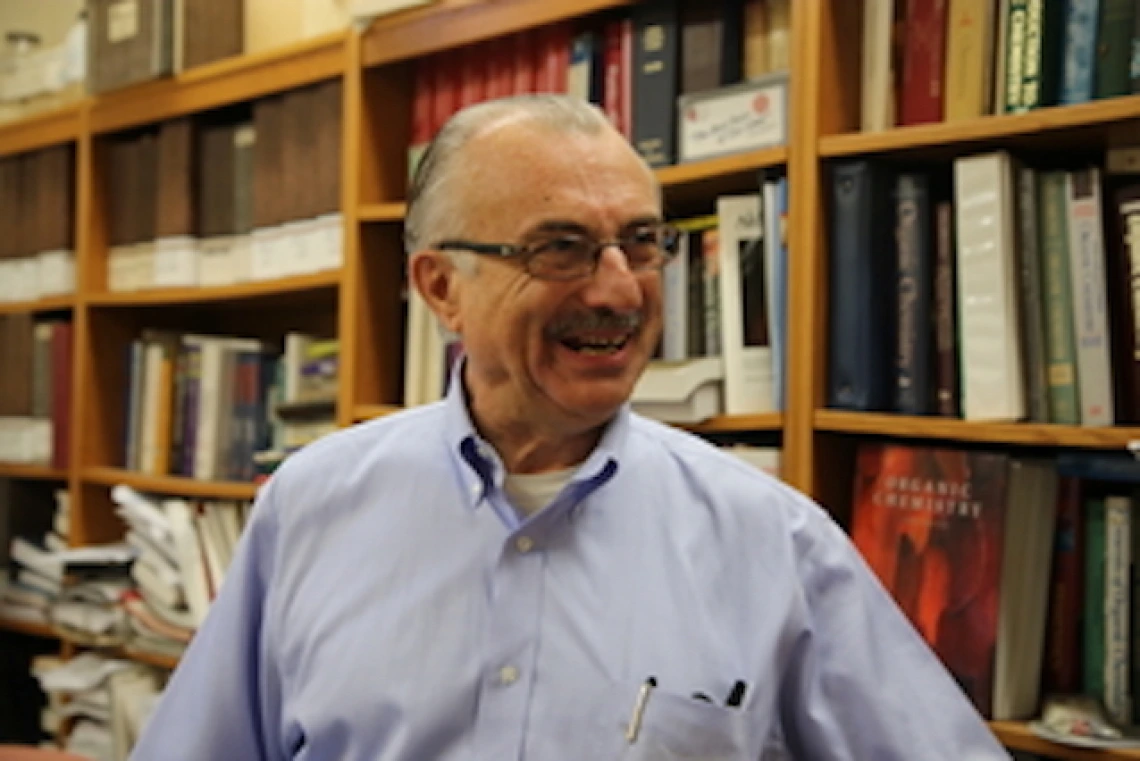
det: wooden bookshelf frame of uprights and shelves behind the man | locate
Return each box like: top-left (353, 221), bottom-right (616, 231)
top-left (0, 0), bottom-right (1140, 761)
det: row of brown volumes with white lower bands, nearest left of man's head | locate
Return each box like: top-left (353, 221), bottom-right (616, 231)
top-left (107, 80), bottom-right (343, 291)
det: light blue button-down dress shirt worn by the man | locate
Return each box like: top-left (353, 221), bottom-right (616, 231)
top-left (131, 384), bottom-right (1008, 761)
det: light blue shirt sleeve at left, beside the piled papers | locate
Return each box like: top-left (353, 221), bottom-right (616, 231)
top-left (130, 478), bottom-right (287, 761)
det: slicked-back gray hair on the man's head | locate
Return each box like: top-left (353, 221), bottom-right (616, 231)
top-left (404, 93), bottom-right (633, 258)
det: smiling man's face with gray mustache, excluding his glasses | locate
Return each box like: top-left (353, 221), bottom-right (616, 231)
top-left (428, 123), bottom-right (661, 432)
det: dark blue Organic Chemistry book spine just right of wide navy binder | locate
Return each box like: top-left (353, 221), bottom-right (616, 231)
top-left (895, 174), bottom-right (933, 415)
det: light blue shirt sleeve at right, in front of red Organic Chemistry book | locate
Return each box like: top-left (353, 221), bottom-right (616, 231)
top-left (781, 505), bottom-right (1009, 761)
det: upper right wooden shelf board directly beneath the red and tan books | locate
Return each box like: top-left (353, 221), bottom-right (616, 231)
top-left (820, 96), bottom-right (1140, 158)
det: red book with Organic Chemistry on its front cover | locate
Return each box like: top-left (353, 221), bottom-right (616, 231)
top-left (852, 444), bottom-right (1009, 715)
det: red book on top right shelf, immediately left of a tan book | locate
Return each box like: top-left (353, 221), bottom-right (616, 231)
top-left (898, 0), bottom-right (948, 126)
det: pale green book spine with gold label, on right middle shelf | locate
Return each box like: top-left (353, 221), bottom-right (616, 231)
top-left (1037, 172), bottom-right (1081, 425)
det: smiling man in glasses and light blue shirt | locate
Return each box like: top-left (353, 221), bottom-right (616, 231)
top-left (133, 96), bottom-right (1007, 761)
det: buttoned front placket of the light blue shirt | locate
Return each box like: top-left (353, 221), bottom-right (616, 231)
top-left (474, 529), bottom-right (546, 761)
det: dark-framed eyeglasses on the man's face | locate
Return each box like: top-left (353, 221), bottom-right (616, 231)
top-left (434, 223), bottom-right (681, 280)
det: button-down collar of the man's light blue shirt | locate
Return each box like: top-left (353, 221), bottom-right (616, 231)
top-left (443, 357), bottom-right (632, 509)
